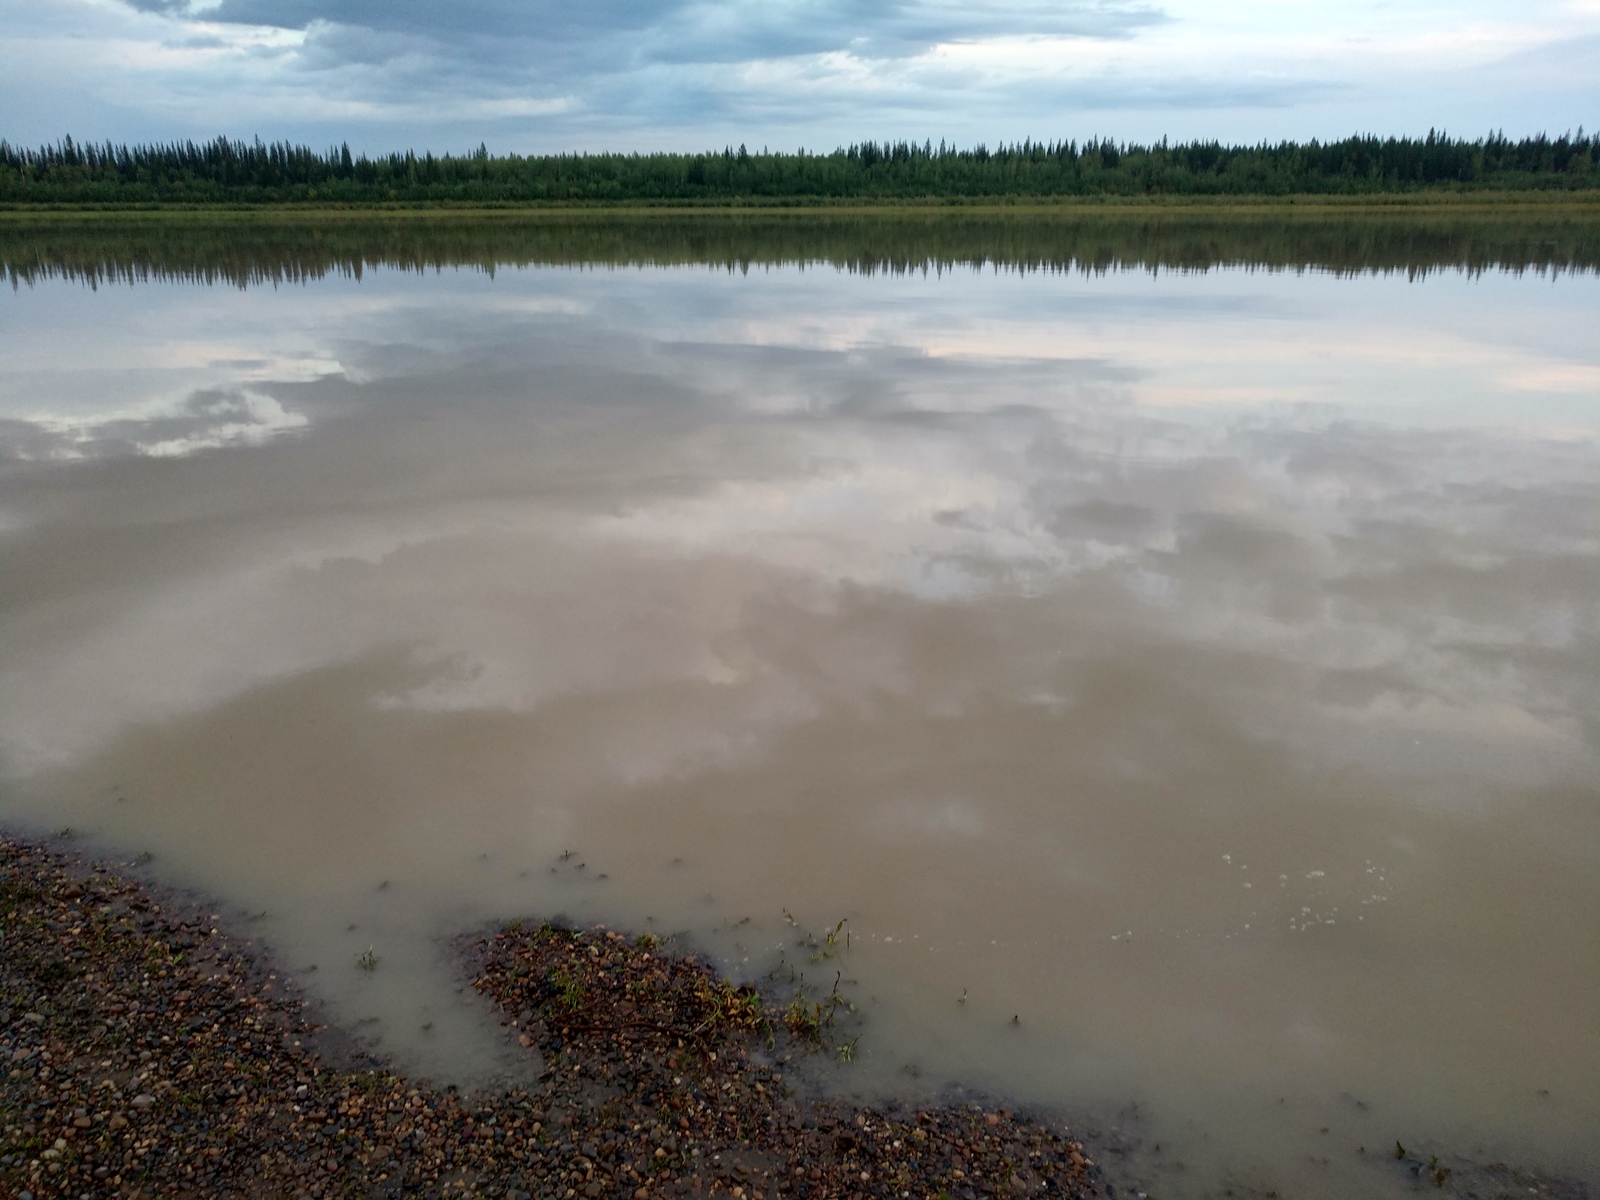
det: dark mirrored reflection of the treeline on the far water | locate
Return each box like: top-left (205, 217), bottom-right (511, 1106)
top-left (0, 200), bottom-right (1600, 291)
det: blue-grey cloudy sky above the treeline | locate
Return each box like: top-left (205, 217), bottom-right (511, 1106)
top-left (0, 0), bottom-right (1600, 152)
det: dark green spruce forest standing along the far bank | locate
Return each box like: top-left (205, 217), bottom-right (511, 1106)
top-left (0, 130), bottom-right (1600, 206)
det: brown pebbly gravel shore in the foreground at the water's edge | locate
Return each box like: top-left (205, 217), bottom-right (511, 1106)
top-left (0, 837), bottom-right (1101, 1200)
